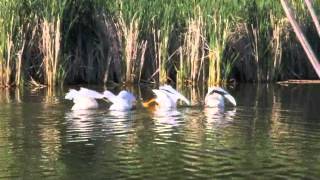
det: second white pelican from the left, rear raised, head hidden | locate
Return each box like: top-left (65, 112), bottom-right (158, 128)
top-left (103, 90), bottom-right (136, 111)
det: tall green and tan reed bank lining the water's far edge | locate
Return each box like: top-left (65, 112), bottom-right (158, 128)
top-left (0, 0), bottom-right (320, 87)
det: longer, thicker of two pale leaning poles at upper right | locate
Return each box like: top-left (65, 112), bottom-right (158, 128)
top-left (281, 0), bottom-right (320, 78)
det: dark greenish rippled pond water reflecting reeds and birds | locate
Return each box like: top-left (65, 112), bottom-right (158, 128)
top-left (0, 85), bottom-right (320, 179)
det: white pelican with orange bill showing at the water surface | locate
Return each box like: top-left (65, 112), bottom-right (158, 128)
top-left (143, 85), bottom-right (190, 110)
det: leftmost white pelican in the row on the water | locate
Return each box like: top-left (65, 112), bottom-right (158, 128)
top-left (65, 87), bottom-right (104, 110)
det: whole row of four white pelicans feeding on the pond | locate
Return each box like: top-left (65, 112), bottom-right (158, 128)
top-left (65, 85), bottom-right (237, 111)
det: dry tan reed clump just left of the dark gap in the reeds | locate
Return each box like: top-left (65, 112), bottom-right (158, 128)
top-left (39, 0), bottom-right (72, 87)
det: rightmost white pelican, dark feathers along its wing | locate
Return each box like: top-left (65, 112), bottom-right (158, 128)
top-left (204, 87), bottom-right (237, 108)
